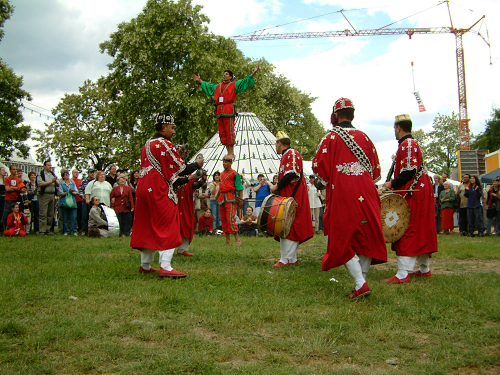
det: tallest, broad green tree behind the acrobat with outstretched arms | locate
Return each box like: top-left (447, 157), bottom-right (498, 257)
top-left (100, 0), bottom-right (324, 164)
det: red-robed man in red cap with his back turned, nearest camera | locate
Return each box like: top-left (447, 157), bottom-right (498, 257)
top-left (313, 98), bottom-right (387, 299)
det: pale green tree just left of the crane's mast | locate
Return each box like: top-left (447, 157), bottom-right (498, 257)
top-left (422, 112), bottom-right (460, 175)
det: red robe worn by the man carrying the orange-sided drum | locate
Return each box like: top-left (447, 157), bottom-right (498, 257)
top-left (274, 148), bottom-right (314, 243)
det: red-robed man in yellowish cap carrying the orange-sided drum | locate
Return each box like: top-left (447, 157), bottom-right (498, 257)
top-left (270, 132), bottom-right (314, 268)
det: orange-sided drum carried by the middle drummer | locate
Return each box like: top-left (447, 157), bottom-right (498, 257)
top-left (257, 194), bottom-right (297, 238)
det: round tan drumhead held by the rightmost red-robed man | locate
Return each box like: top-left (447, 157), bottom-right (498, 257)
top-left (380, 193), bottom-right (410, 243)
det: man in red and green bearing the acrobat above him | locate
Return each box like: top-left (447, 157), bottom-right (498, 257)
top-left (217, 157), bottom-right (243, 246)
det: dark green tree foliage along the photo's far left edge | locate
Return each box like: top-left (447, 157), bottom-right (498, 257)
top-left (0, 0), bottom-right (31, 159)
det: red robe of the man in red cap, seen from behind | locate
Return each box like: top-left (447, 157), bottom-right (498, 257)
top-left (313, 128), bottom-right (387, 271)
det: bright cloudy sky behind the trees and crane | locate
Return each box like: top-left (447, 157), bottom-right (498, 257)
top-left (0, 0), bottom-right (500, 171)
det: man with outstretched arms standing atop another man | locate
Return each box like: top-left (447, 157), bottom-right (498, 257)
top-left (191, 65), bottom-right (259, 160)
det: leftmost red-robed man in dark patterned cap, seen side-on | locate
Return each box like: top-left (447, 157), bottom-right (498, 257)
top-left (130, 113), bottom-right (203, 278)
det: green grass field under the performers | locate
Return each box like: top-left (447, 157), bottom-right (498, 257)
top-left (0, 235), bottom-right (500, 375)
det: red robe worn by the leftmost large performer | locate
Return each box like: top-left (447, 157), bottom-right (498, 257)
top-left (130, 137), bottom-right (185, 250)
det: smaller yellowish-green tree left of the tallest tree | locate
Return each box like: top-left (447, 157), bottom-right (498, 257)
top-left (34, 81), bottom-right (134, 170)
